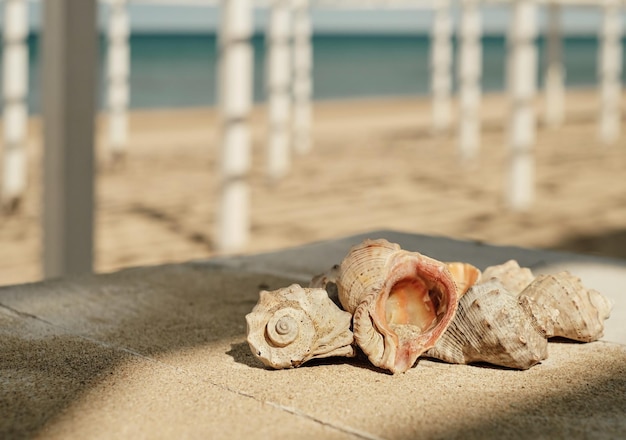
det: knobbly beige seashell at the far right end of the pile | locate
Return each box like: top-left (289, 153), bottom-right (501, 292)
top-left (519, 271), bottom-right (612, 342)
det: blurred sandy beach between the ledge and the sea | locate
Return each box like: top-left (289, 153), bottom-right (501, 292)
top-left (0, 90), bottom-right (626, 284)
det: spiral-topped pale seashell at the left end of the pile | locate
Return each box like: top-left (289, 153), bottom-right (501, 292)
top-left (246, 284), bottom-right (354, 368)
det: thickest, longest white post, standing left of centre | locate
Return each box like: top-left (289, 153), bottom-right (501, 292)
top-left (216, 0), bottom-right (253, 252)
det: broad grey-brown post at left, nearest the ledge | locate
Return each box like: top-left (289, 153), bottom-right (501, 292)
top-left (42, 0), bottom-right (97, 278)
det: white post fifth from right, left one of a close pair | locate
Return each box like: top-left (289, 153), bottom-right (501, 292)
top-left (430, 0), bottom-right (452, 133)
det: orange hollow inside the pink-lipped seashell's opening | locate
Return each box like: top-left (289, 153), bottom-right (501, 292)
top-left (385, 278), bottom-right (445, 332)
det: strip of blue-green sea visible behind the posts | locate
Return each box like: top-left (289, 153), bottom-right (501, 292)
top-left (0, 34), bottom-right (626, 114)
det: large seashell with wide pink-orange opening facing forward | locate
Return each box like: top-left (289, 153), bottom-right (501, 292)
top-left (337, 240), bottom-right (458, 373)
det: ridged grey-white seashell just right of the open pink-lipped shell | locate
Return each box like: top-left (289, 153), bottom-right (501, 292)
top-left (426, 279), bottom-right (548, 370)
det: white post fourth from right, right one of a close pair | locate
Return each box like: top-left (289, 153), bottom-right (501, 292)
top-left (459, 0), bottom-right (482, 161)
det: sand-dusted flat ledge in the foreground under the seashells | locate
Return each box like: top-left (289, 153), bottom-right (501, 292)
top-left (0, 231), bottom-right (626, 439)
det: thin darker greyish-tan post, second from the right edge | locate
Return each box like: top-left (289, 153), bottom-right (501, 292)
top-left (544, 3), bottom-right (565, 127)
